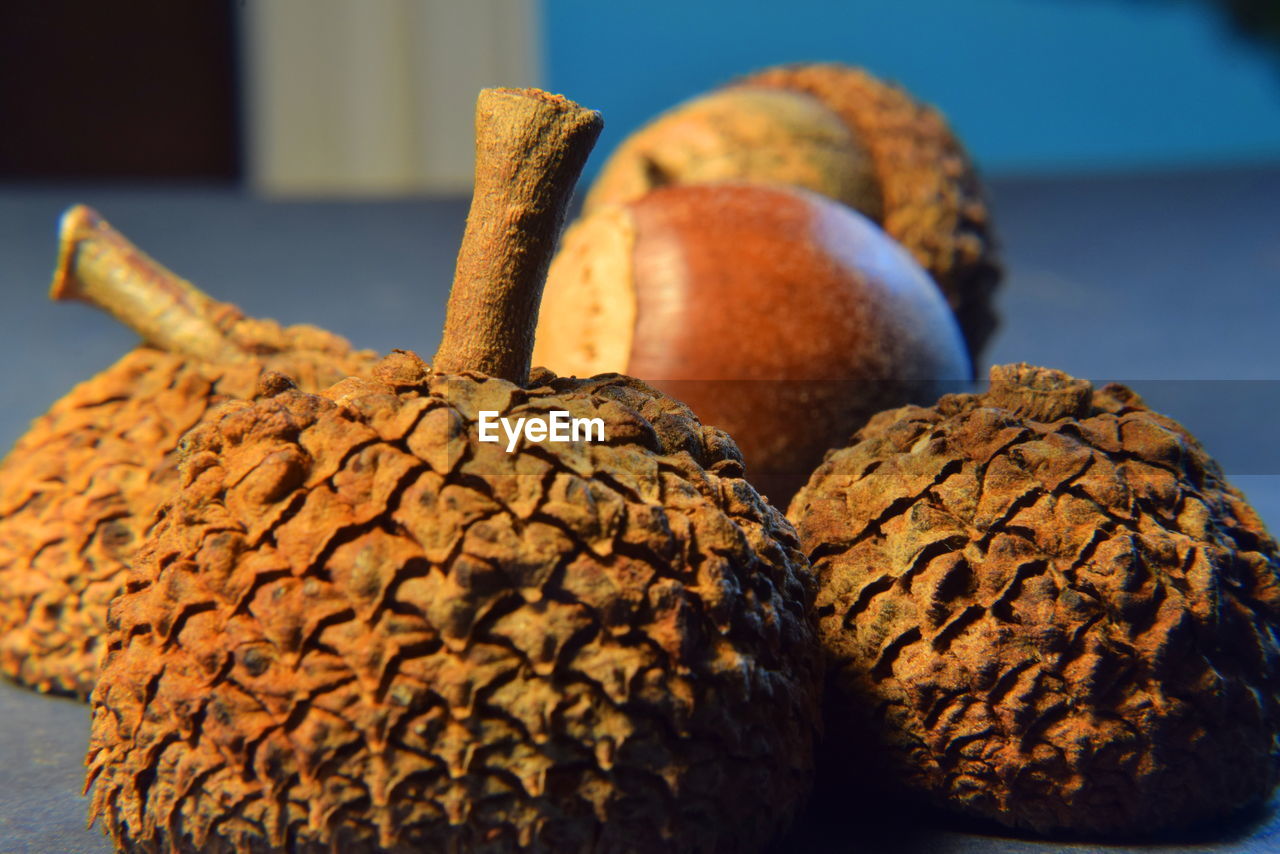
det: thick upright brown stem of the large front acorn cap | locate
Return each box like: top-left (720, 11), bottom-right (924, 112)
top-left (431, 88), bottom-right (604, 385)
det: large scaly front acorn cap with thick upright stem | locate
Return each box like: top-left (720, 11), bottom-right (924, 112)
top-left (88, 90), bottom-right (820, 853)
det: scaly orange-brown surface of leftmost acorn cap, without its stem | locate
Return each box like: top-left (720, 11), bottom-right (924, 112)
top-left (0, 320), bottom-right (374, 697)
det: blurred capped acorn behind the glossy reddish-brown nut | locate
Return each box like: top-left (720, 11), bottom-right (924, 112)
top-left (584, 64), bottom-right (1000, 361)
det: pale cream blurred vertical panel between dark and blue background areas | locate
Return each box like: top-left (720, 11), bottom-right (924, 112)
top-left (242, 0), bottom-right (541, 196)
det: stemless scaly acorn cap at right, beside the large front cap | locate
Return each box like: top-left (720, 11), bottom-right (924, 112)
top-left (790, 365), bottom-right (1280, 836)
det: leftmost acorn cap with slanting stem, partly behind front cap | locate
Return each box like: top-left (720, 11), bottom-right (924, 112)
top-left (0, 205), bottom-right (375, 697)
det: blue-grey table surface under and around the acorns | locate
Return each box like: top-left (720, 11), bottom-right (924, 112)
top-left (0, 166), bottom-right (1280, 854)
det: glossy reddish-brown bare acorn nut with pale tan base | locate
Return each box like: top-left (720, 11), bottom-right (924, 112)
top-left (534, 184), bottom-right (972, 506)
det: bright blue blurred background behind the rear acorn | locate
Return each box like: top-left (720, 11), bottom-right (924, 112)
top-left (543, 0), bottom-right (1280, 174)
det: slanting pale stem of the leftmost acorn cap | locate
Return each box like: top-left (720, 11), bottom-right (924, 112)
top-left (49, 205), bottom-right (248, 362)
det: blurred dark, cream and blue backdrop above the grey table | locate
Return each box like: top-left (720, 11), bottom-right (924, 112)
top-left (0, 0), bottom-right (1280, 186)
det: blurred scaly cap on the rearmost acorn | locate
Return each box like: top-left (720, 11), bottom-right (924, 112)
top-left (735, 64), bottom-right (1000, 362)
